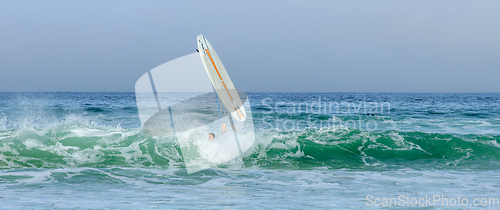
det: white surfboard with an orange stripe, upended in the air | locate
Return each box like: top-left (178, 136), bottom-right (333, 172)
top-left (197, 34), bottom-right (247, 121)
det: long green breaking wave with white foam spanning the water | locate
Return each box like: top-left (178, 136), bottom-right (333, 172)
top-left (0, 123), bottom-right (500, 169)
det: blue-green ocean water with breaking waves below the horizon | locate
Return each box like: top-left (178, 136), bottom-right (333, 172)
top-left (0, 93), bottom-right (500, 209)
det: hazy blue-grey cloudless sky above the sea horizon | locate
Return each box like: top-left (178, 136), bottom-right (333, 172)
top-left (0, 0), bottom-right (500, 93)
